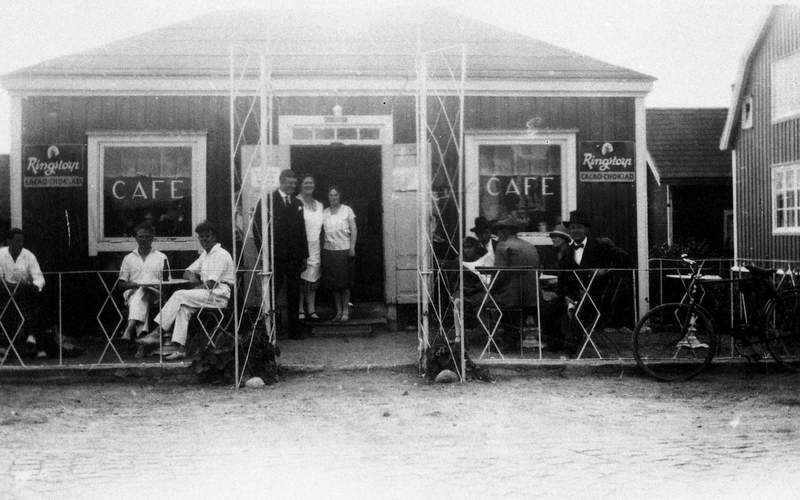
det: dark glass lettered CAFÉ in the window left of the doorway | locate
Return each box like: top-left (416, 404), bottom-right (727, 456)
top-left (103, 146), bottom-right (192, 238)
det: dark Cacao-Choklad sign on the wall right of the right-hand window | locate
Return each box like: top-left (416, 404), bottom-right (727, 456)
top-left (578, 141), bottom-right (636, 182)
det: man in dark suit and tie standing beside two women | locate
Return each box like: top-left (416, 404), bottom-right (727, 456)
top-left (254, 169), bottom-right (308, 339)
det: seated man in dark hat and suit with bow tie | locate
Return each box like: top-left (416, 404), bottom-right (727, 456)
top-left (558, 210), bottom-right (630, 356)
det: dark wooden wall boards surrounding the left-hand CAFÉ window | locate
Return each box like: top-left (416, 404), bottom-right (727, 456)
top-left (22, 96), bottom-right (231, 271)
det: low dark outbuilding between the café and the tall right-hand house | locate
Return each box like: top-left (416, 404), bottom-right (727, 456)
top-left (647, 108), bottom-right (733, 254)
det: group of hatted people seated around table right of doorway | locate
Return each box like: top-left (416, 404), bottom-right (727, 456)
top-left (443, 210), bottom-right (631, 356)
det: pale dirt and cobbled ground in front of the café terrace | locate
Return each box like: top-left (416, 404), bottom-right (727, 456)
top-left (0, 366), bottom-right (800, 499)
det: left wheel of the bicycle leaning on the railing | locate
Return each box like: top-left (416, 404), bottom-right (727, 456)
top-left (633, 303), bottom-right (717, 382)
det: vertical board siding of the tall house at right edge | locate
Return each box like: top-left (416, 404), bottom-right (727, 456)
top-left (736, 8), bottom-right (800, 262)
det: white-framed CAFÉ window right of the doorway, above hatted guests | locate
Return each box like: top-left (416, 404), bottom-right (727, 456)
top-left (466, 133), bottom-right (575, 232)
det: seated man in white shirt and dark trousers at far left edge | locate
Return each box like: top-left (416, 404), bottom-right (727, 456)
top-left (0, 227), bottom-right (47, 357)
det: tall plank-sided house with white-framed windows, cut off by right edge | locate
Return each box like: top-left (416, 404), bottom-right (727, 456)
top-left (720, 5), bottom-right (800, 265)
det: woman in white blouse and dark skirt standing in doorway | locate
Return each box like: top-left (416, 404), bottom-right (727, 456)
top-left (322, 186), bottom-right (358, 323)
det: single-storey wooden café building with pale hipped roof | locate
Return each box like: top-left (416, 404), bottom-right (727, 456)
top-left (2, 9), bottom-right (654, 328)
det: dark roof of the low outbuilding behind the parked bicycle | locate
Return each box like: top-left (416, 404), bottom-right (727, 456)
top-left (647, 108), bottom-right (731, 180)
